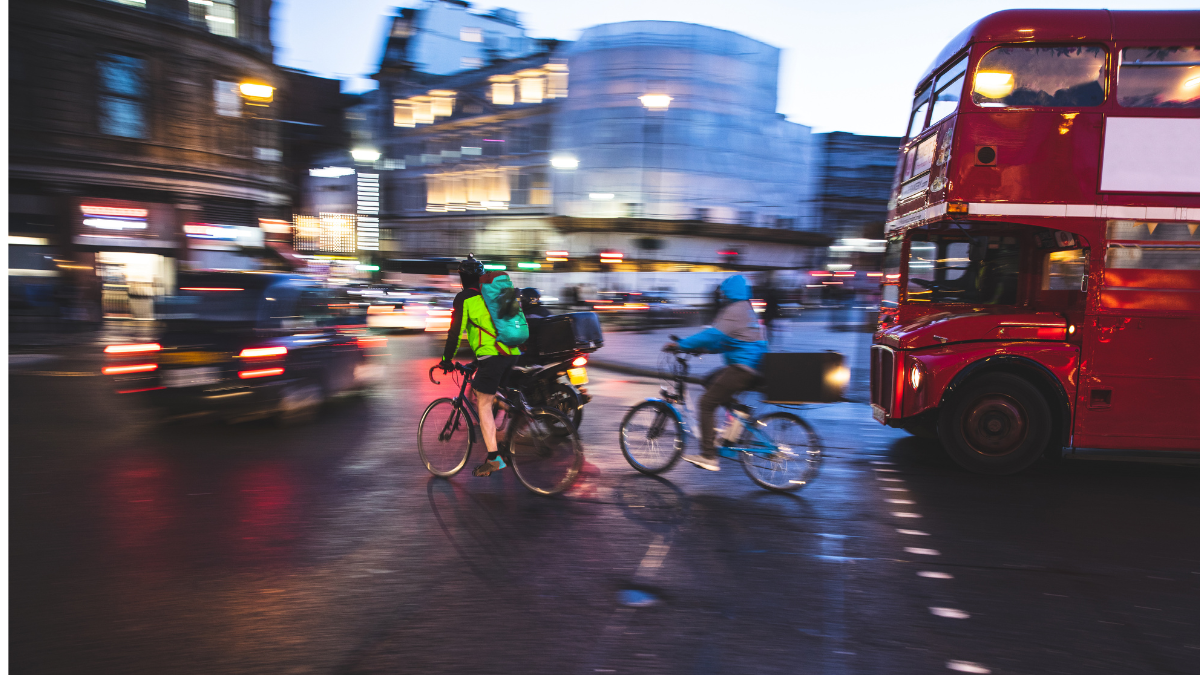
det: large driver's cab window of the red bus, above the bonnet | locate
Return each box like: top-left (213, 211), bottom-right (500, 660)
top-left (907, 232), bottom-right (1020, 305)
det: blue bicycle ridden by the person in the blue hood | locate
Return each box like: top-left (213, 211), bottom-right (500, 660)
top-left (620, 351), bottom-right (824, 492)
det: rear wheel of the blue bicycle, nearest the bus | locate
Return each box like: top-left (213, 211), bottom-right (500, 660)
top-left (739, 412), bottom-right (823, 492)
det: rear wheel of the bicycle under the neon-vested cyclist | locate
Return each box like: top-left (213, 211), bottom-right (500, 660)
top-left (509, 408), bottom-right (583, 495)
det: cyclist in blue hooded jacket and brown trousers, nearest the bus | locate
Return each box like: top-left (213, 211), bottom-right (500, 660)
top-left (662, 274), bottom-right (769, 471)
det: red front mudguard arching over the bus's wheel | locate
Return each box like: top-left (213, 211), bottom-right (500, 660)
top-left (895, 342), bottom-right (1079, 420)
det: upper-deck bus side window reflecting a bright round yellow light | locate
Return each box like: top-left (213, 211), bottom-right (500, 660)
top-left (971, 47), bottom-right (1105, 108)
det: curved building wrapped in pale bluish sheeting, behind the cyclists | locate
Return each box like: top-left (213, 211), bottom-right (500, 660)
top-left (553, 22), bottom-right (812, 228)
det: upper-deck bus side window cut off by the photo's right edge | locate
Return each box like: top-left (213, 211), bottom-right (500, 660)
top-left (1117, 47), bottom-right (1200, 108)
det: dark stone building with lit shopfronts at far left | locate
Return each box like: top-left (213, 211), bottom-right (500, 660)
top-left (8, 0), bottom-right (290, 319)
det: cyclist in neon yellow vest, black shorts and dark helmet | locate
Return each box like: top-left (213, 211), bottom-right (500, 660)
top-left (440, 255), bottom-right (521, 477)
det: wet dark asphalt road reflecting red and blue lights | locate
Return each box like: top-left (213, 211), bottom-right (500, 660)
top-left (10, 322), bottom-right (1200, 675)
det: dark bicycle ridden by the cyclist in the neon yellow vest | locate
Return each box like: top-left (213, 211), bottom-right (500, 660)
top-left (416, 363), bottom-right (583, 495)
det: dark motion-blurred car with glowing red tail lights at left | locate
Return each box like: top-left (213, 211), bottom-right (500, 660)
top-left (102, 273), bottom-right (386, 420)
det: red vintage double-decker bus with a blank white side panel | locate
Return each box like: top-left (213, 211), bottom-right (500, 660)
top-left (871, 10), bottom-right (1200, 473)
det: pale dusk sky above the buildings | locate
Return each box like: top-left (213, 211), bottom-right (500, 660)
top-left (274, 0), bottom-right (1196, 136)
